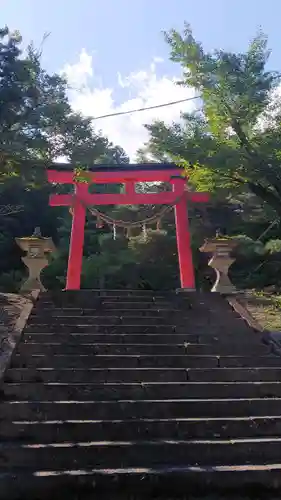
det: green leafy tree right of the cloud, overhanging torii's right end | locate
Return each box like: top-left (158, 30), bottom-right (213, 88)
top-left (140, 24), bottom-right (281, 217)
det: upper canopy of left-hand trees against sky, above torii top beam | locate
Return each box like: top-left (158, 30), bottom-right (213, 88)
top-left (0, 27), bottom-right (128, 183)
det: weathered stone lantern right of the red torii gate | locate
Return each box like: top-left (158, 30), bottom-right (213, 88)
top-left (200, 237), bottom-right (238, 294)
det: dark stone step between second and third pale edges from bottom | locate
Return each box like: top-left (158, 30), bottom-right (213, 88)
top-left (0, 416), bottom-right (281, 444)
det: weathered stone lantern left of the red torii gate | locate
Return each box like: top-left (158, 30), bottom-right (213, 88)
top-left (16, 228), bottom-right (56, 292)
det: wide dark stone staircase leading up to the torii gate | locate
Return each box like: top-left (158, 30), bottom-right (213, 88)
top-left (0, 290), bottom-right (281, 500)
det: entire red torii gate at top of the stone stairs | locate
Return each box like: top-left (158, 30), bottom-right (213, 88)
top-left (47, 163), bottom-right (209, 290)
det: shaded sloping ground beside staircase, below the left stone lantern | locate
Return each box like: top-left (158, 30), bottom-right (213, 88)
top-left (0, 293), bottom-right (31, 376)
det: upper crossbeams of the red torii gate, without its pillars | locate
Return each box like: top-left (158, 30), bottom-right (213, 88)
top-left (47, 163), bottom-right (209, 206)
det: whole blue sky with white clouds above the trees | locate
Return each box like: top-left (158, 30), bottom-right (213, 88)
top-left (0, 0), bottom-right (281, 155)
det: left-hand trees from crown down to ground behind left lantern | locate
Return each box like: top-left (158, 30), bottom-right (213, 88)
top-left (0, 28), bottom-right (129, 291)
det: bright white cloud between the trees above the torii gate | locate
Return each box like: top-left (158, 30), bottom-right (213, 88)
top-left (63, 49), bottom-right (195, 159)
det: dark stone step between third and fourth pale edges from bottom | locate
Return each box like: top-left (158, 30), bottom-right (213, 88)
top-left (0, 398), bottom-right (281, 423)
